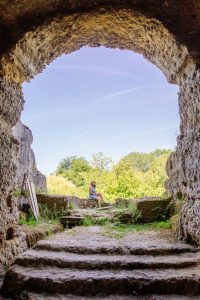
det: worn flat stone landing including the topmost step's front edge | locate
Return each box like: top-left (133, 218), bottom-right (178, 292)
top-left (36, 226), bottom-right (199, 255)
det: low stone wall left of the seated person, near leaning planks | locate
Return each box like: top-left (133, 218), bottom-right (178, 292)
top-left (37, 194), bottom-right (98, 209)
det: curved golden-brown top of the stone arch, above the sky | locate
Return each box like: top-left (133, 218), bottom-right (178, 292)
top-left (2, 9), bottom-right (188, 83)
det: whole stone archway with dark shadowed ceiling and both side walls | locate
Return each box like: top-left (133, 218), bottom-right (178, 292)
top-left (0, 0), bottom-right (200, 270)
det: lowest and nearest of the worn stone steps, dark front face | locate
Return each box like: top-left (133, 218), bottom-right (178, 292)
top-left (2, 265), bottom-right (200, 299)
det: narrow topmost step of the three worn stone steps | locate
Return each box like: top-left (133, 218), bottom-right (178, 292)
top-left (35, 239), bottom-right (199, 255)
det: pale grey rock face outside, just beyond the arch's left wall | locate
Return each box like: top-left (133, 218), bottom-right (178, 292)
top-left (13, 121), bottom-right (47, 192)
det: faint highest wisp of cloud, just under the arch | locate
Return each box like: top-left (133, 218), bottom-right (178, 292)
top-left (49, 65), bottom-right (141, 79)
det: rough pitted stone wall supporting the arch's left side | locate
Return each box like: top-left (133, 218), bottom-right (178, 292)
top-left (0, 78), bottom-right (24, 272)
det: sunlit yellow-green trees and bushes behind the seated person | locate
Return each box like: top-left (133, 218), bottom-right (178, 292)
top-left (47, 149), bottom-right (172, 201)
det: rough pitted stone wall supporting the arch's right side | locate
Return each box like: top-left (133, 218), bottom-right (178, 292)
top-left (167, 65), bottom-right (200, 245)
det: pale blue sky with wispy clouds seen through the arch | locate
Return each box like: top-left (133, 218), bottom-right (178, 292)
top-left (22, 47), bottom-right (179, 174)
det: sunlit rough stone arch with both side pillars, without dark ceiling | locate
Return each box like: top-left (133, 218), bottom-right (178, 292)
top-left (0, 3), bottom-right (199, 274)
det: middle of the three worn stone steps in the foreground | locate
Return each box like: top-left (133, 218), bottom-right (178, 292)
top-left (15, 250), bottom-right (197, 270)
